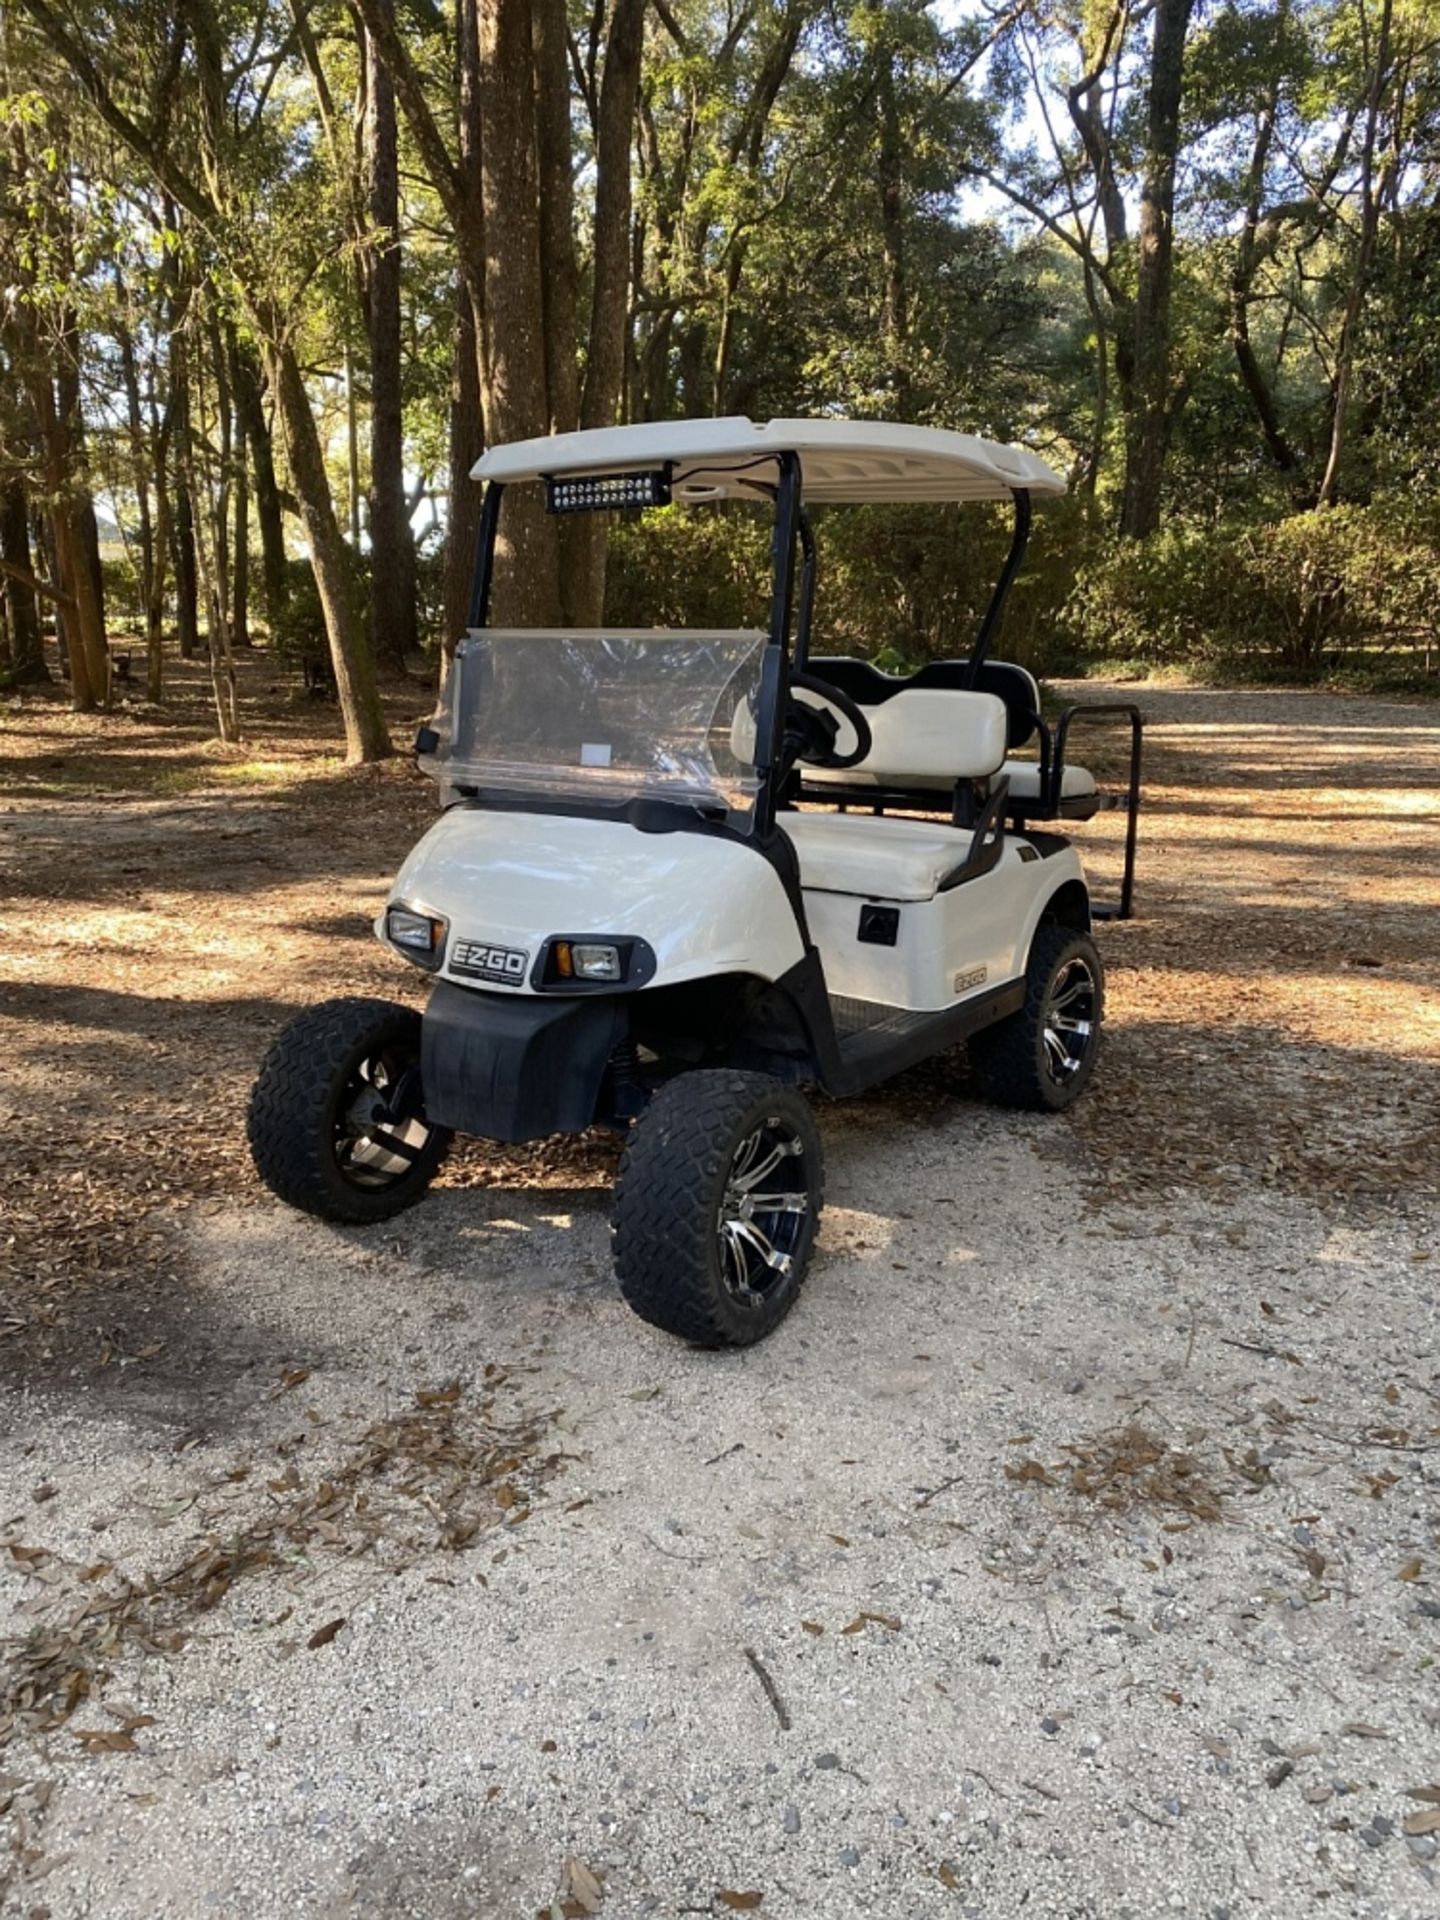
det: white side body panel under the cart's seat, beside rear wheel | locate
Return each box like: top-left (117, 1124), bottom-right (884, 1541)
top-left (804, 837), bottom-right (1083, 1012)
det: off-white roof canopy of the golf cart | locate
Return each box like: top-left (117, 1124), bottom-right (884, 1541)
top-left (470, 415), bottom-right (1066, 505)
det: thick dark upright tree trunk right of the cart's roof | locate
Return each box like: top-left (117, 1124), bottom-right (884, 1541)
top-left (1119, 0), bottom-right (1194, 540)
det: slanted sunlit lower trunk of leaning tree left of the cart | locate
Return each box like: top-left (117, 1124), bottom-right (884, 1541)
top-left (271, 341), bottom-right (392, 764)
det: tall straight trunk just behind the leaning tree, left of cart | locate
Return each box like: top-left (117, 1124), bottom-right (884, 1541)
top-left (365, 0), bottom-right (420, 668)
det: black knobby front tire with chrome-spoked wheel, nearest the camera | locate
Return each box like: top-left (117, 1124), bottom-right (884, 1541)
top-left (612, 1069), bottom-right (826, 1346)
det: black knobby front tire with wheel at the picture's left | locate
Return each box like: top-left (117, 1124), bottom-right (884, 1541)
top-left (246, 998), bottom-right (449, 1225)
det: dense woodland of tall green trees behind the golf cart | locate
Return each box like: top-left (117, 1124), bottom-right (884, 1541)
top-left (0, 0), bottom-right (1440, 758)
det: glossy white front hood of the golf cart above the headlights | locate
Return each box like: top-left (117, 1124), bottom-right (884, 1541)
top-left (389, 806), bottom-right (804, 995)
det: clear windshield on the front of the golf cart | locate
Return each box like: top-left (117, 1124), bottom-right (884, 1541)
top-left (422, 628), bottom-right (764, 808)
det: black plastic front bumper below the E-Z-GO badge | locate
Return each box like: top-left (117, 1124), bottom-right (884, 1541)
top-left (420, 979), bottom-right (628, 1142)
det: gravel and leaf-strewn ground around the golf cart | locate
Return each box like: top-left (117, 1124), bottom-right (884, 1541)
top-left (0, 668), bottom-right (1440, 1920)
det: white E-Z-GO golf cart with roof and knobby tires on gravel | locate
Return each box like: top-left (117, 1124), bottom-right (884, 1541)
top-left (250, 419), bottom-right (1140, 1346)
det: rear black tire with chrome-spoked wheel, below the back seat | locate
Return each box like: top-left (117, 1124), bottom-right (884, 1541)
top-left (970, 925), bottom-right (1104, 1114)
